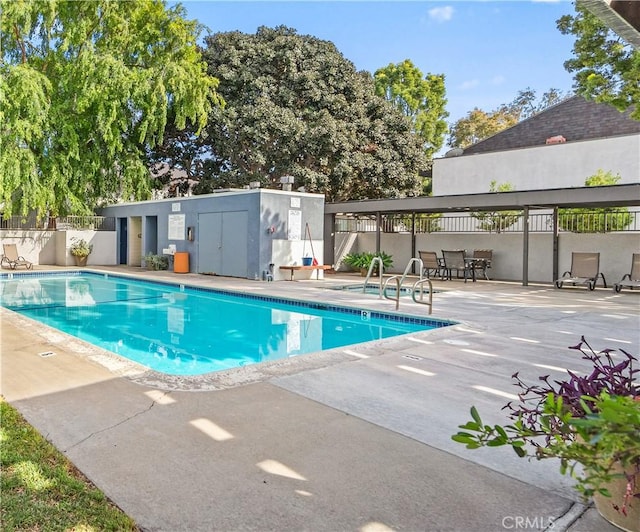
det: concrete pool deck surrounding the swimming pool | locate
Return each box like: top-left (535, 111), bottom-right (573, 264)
top-left (0, 268), bottom-right (640, 532)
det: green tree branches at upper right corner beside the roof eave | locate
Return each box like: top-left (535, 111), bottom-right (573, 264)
top-left (557, 3), bottom-right (640, 120)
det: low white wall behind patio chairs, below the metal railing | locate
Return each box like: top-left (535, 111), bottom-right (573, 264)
top-left (336, 232), bottom-right (640, 284)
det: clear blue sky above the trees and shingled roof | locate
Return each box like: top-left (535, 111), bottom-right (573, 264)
top-left (181, 0), bottom-right (575, 143)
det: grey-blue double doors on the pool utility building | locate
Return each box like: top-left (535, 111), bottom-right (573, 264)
top-left (197, 211), bottom-right (249, 278)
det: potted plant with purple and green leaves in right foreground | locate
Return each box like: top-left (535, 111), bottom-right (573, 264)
top-left (452, 337), bottom-right (640, 532)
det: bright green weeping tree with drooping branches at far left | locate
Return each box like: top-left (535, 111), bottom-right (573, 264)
top-left (0, 0), bottom-right (217, 215)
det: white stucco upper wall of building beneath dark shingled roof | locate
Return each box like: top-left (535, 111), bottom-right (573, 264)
top-left (433, 135), bottom-right (640, 199)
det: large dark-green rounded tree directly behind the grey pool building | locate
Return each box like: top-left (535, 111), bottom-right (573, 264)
top-left (198, 27), bottom-right (426, 201)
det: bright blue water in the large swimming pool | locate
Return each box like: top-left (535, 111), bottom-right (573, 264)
top-left (0, 272), bottom-right (451, 375)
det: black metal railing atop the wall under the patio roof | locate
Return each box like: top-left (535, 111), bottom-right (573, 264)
top-left (335, 209), bottom-right (640, 233)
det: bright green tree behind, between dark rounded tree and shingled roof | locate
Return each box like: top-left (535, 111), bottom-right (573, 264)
top-left (374, 59), bottom-right (449, 159)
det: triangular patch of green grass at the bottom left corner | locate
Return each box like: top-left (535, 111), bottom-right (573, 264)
top-left (0, 397), bottom-right (138, 532)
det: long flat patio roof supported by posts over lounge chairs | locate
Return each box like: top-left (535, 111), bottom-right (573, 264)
top-left (324, 183), bottom-right (640, 214)
